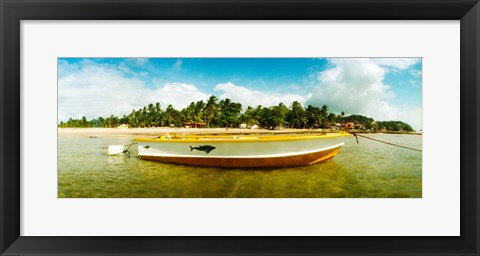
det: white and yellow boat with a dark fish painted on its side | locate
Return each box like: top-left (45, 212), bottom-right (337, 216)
top-left (136, 133), bottom-right (351, 167)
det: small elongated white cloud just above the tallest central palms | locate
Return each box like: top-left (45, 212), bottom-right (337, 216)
top-left (214, 82), bottom-right (307, 110)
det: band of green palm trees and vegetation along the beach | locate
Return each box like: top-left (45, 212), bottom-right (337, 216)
top-left (58, 96), bottom-right (413, 131)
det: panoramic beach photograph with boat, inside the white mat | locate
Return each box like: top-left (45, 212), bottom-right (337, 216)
top-left (57, 57), bottom-right (422, 198)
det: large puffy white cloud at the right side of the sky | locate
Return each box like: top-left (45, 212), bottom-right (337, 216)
top-left (306, 58), bottom-right (422, 129)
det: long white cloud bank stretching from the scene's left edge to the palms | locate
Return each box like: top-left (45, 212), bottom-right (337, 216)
top-left (58, 61), bottom-right (210, 121)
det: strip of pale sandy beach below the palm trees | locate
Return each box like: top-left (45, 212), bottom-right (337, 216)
top-left (58, 127), bottom-right (422, 136)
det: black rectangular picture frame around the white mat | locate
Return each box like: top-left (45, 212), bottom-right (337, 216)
top-left (0, 0), bottom-right (480, 255)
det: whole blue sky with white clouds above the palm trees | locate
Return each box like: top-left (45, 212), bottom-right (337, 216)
top-left (58, 58), bottom-right (422, 129)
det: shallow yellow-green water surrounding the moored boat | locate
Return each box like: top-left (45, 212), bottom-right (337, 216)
top-left (58, 134), bottom-right (422, 198)
